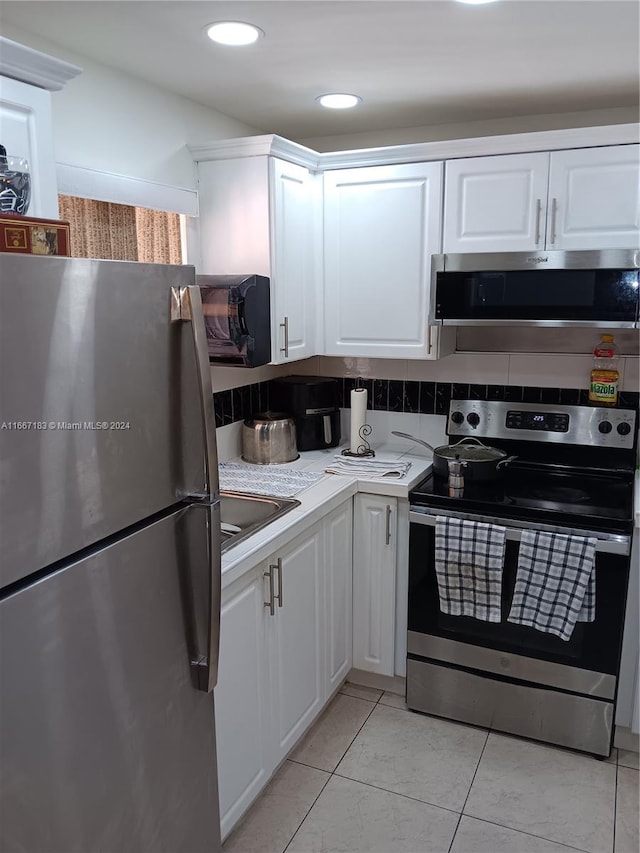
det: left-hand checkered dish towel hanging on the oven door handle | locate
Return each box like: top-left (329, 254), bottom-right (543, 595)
top-left (436, 516), bottom-right (506, 622)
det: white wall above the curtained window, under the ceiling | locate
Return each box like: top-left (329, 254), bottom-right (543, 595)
top-left (2, 24), bottom-right (261, 189)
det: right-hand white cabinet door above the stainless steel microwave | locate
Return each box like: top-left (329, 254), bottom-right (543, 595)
top-left (547, 145), bottom-right (640, 249)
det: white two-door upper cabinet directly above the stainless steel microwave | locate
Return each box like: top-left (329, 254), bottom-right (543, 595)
top-left (443, 145), bottom-right (640, 253)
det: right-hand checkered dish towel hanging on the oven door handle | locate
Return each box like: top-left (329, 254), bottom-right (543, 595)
top-left (508, 530), bottom-right (597, 640)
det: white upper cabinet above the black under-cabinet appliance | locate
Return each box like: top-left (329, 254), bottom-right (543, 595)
top-left (197, 156), bottom-right (320, 364)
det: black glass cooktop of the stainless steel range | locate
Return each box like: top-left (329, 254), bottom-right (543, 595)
top-left (409, 463), bottom-right (633, 533)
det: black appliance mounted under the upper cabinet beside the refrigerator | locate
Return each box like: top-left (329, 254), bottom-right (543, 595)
top-left (196, 275), bottom-right (271, 367)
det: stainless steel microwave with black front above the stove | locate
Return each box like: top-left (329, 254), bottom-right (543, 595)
top-left (429, 249), bottom-right (640, 329)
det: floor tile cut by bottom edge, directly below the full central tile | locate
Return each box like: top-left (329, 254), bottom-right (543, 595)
top-left (287, 776), bottom-right (458, 853)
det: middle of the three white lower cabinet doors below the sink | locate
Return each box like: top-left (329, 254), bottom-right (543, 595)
top-left (269, 524), bottom-right (324, 764)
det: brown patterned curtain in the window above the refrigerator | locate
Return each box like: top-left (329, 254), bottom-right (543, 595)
top-left (58, 195), bottom-right (182, 264)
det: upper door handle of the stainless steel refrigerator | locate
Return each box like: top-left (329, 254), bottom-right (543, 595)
top-left (171, 284), bottom-right (219, 502)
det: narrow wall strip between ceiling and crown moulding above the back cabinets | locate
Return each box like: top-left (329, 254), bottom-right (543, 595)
top-left (294, 107), bottom-right (640, 152)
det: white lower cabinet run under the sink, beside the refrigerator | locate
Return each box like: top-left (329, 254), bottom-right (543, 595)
top-left (215, 499), bottom-right (352, 838)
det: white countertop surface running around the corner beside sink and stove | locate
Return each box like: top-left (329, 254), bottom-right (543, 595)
top-left (222, 445), bottom-right (431, 589)
